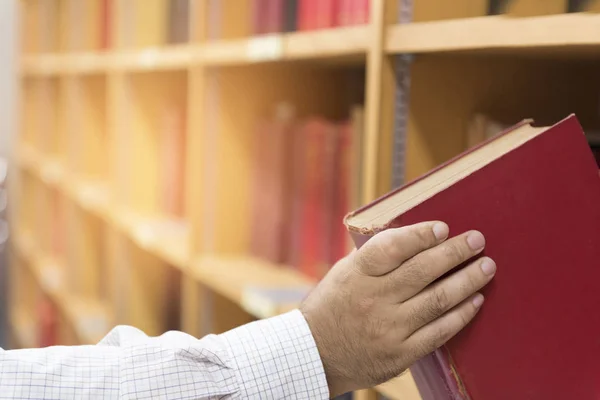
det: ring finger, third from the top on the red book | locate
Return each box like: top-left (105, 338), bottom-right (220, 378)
top-left (402, 257), bottom-right (496, 334)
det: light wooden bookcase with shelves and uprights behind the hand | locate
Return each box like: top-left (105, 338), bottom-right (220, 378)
top-left (10, 0), bottom-right (600, 400)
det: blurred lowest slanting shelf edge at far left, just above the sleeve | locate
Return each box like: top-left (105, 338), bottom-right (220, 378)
top-left (13, 232), bottom-right (112, 347)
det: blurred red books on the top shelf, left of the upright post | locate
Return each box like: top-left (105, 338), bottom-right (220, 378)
top-left (251, 0), bottom-right (370, 35)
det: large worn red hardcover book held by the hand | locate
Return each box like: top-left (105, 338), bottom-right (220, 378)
top-left (345, 116), bottom-right (600, 400)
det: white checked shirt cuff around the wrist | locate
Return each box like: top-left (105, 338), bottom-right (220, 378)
top-left (221, 310), bottom-right (329, 399)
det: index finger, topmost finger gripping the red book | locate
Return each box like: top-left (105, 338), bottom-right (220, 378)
top-left (353, 221), bottom-right (448, 276)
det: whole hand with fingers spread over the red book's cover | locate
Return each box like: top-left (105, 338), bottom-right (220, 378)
top-left (300, 221), bottom-right (496, 397)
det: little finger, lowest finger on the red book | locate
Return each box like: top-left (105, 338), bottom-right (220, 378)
top-left (405, 293), bottom-right (484, 360)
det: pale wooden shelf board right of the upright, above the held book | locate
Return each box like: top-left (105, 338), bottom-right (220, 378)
top-left (385, 13), bottom-right (600, 55)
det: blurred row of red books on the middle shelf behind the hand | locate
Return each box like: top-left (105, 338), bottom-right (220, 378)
top-left (251, 104), bottom-right (362, 279)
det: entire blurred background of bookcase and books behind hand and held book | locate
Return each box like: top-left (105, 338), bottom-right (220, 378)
top-left (5, 0), bottom-right (600, 400)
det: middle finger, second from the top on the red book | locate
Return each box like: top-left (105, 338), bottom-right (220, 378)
top-left (389, 231), bottom-right (485, 301)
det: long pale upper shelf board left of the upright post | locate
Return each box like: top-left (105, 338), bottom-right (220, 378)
top-left (21, 26), bottom-right (369, 76)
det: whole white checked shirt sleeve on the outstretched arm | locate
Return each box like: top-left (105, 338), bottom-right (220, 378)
top-left (0, 310), bottom-right (329, 400)
